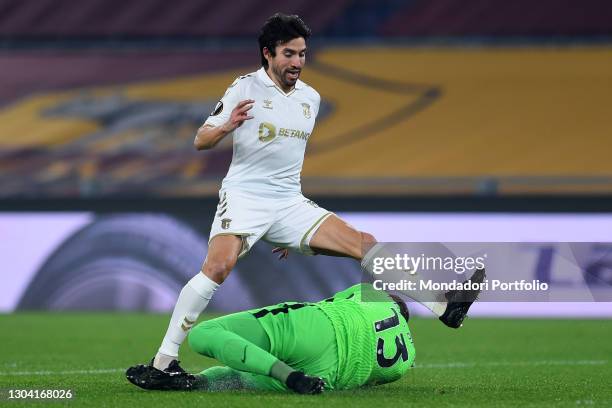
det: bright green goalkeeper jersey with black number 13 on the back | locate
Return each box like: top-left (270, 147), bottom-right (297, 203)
top-left (317, 284), bottom-right (415, 389)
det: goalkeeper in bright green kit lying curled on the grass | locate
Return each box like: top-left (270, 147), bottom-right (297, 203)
top-left (126, 284), bottom-right (415, 394)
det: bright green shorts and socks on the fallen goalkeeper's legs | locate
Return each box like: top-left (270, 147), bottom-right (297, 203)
top-left (189, 306), bottom-right (338, 391)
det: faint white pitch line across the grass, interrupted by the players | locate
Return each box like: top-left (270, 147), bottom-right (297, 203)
top-left (0, 360), bottom-right (608, 376)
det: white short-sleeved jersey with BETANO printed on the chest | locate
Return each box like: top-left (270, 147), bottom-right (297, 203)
top-left (205, 67), bottom-right (321, 197)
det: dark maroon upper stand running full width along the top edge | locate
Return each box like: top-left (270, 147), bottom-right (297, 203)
top-left (0, 0), bottom-right (612, 40)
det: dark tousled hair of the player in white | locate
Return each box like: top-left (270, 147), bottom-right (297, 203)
top-left (257, 13), bottom-right (311, 69)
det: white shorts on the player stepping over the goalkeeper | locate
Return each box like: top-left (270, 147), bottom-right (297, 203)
top-left (209, 189), bottom-right (332, 257)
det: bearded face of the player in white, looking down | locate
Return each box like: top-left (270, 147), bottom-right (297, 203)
top-left (268, 37), bottom-right (306, 90)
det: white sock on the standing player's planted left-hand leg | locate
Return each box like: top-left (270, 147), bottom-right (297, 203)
top-left (153, 272), bottom-right (219, 370)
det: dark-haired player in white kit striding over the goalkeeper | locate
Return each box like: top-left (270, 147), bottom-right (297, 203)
top-left (128, 14), bottom-right (482, 386)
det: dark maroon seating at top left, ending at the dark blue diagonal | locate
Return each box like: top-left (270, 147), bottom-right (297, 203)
top-left (0, 0), bottom-right (350, 39)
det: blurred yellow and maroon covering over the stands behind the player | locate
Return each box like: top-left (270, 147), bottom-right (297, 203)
top-left (0, 47), bottom-right (612, 195)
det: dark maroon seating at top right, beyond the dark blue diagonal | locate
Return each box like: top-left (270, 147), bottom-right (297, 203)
top-left (378, 0), bottom-right (612, 37)
